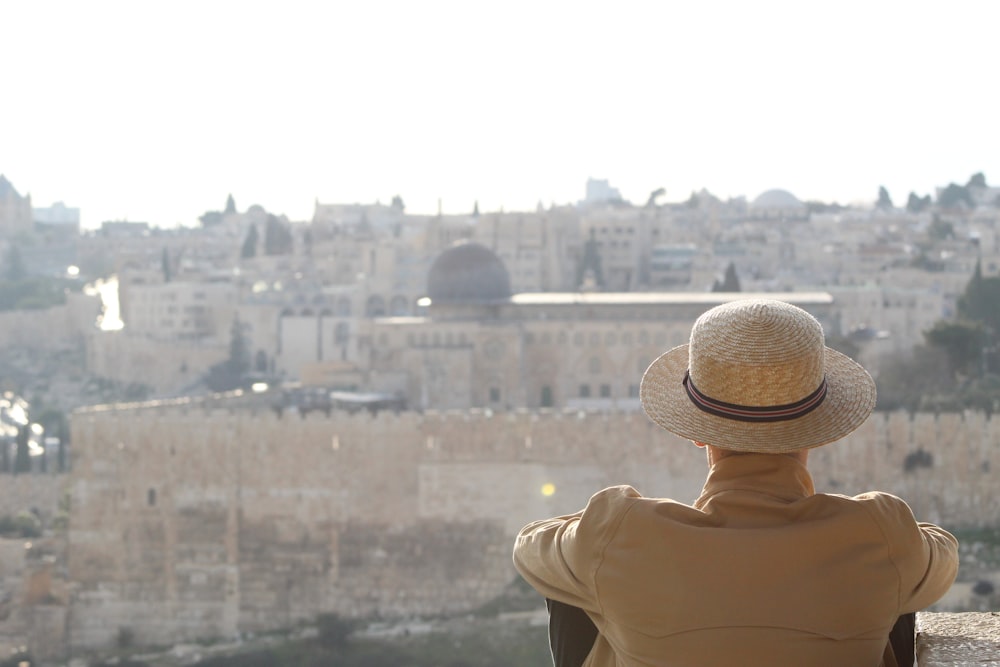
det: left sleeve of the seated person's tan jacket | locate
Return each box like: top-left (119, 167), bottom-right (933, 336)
top-left (514, 486), bottom-right (640, 613)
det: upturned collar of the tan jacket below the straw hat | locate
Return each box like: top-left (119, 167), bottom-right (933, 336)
top-left (694, 454), bottom-right (816, 509)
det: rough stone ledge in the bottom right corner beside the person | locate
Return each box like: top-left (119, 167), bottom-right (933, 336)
top-left (917, 611), bottom-right (1000, 667)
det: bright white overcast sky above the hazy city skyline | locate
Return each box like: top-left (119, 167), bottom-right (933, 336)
top-left (0, 0), bottom-right (1000, 227)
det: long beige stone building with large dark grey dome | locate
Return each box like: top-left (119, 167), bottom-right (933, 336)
top-left (294, 243), bottom-right (834, 410)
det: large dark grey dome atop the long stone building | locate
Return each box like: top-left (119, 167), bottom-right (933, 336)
top-left (427, 241), bottom-right (510, 304)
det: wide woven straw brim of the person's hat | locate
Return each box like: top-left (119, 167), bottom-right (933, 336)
top-left (639, 345), bottom-right (876, 453)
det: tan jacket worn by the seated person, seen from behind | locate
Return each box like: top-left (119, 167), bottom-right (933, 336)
top-left (514, 454), bottom-right (958, 667)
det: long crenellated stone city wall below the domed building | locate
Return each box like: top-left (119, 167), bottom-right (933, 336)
top-left (68, 403), bottom-right (1000, 648)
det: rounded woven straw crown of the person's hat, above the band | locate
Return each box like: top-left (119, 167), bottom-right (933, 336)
top-left (688, 300), bottom-right (825, 407)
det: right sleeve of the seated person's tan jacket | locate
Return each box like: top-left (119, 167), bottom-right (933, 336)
top-left (856, 492), bottom-right (958, 614)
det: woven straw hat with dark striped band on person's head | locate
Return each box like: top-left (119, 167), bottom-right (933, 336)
top-left (639, 299), bottom-right (875, 453)
